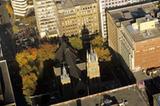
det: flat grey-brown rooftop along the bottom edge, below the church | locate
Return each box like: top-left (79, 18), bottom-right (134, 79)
top-left (51, 84), bottom-right (148, 106)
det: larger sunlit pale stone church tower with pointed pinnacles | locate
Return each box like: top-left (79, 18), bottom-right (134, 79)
top-left (87, 47), bottom-right (100, 79)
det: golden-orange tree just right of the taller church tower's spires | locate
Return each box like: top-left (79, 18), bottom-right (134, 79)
top-left (94, 47), bottom-right (112, 61)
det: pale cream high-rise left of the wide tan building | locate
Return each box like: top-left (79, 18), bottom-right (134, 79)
top-left (34, 0), bottom-right (59, 38)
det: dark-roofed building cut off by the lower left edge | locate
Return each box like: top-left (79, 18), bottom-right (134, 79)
top-left (0, 45), bottom-right (16, 106)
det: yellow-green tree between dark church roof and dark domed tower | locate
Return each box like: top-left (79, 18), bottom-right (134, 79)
top-left (69, 37), bottom-right (83, 50)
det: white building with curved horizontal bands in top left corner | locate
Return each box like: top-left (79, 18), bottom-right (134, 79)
top-left (11, 0), bottom-right (33, 17)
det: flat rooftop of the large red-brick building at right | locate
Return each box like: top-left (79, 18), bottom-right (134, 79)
top-left (109, 2), bottom-right (160, 42)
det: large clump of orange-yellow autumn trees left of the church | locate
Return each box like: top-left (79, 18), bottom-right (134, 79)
top-left (16, 44), bottom-right (57, 102)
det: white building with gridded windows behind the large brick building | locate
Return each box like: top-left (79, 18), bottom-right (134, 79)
top-left (98, 0), bottom-right (145, 38)
